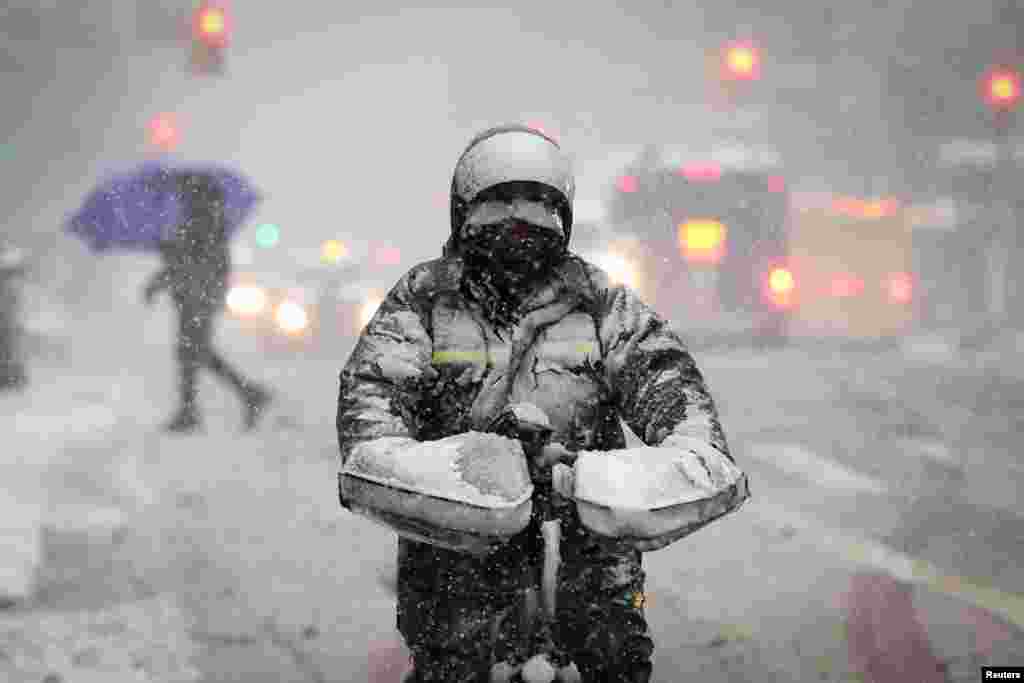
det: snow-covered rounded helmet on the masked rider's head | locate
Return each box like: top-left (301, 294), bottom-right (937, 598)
top-left (452, 124), bottom-right (575, 248)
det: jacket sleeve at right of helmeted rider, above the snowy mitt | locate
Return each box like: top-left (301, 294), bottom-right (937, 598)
top-left (594, 272), bottom-right (733, 462)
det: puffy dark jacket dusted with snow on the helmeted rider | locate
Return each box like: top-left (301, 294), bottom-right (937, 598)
top-left (337, 255), bottom-right (749, 518)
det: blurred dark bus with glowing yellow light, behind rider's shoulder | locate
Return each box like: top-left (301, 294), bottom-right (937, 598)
top-left (606, 145), bottom-right (798, 345)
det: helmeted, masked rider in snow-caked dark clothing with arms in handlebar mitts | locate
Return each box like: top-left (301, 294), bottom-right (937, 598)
top-left (337, 125), bottom-right (750, 683)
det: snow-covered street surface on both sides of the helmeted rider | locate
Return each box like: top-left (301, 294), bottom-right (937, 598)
top-left (0, 313), bottom-right (1024, 683)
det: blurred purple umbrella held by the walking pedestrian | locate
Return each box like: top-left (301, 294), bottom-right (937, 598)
top-left (66, 162), bottom-right (262, 252)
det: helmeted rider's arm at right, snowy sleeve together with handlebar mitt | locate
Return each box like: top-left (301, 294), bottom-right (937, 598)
top-left (574, 272), bottom-right (751, 552)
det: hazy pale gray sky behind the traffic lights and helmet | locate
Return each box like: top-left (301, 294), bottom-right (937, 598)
top-left (3, 0), bottom-right (1006, 274)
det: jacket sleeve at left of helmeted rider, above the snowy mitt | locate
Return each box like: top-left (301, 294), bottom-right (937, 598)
top-left (337, 272), bottom-right (437, 467)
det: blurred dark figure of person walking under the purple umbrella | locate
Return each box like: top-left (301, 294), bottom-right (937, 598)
top-left (144, 173), bottom-right (270, 432)
